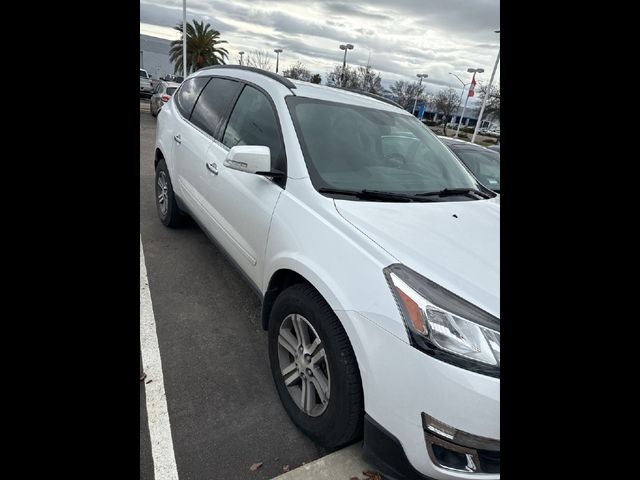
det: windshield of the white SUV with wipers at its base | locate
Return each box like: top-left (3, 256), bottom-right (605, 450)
top-left (286, 96), bottom-right (482, 200)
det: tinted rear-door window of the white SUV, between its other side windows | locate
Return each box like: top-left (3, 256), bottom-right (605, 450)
top-left (191, 78), bottom-right (242, 140)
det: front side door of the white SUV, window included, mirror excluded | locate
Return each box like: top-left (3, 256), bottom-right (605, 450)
top-left (203, 85), bottom-right (286, 288)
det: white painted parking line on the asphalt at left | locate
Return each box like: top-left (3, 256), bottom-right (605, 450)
top-left (140, 236), bottom-right (178, 480)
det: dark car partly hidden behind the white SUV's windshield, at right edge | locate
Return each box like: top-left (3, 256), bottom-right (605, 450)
top-left (438, 136), bottom-right (500, 193)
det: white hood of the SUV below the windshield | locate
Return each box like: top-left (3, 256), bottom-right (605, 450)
top-left (334, 196), bottom-right (500, 318)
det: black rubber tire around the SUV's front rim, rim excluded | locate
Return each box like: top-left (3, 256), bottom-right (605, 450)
top-left (269, 283), bottom-right (364, 449)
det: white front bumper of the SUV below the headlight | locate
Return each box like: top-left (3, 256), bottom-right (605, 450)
top-left (336, 311), bottom-right (500, 480)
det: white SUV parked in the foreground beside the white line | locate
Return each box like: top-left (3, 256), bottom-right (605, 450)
top-left (155, 66), bottom-right (500, 480)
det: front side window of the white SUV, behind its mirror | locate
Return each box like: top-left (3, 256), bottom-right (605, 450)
top-left (222, 85), bottom-right (285, 170)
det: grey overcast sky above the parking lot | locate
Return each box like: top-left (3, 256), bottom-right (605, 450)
top-left (140, 0), bottom-right (500, 92)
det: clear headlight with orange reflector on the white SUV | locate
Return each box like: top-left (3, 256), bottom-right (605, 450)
top-left (384, 264), bottom-right (500, 377)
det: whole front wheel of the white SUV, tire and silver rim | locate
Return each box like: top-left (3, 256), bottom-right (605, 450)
top-left (269, 284), bottom-right (364, 449)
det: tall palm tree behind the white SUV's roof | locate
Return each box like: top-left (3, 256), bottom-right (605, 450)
top-left (169, 20), bottom-right (229, 73)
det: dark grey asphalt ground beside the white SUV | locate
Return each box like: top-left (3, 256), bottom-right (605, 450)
top-left (140, 99), bottom-right (329, 480)
